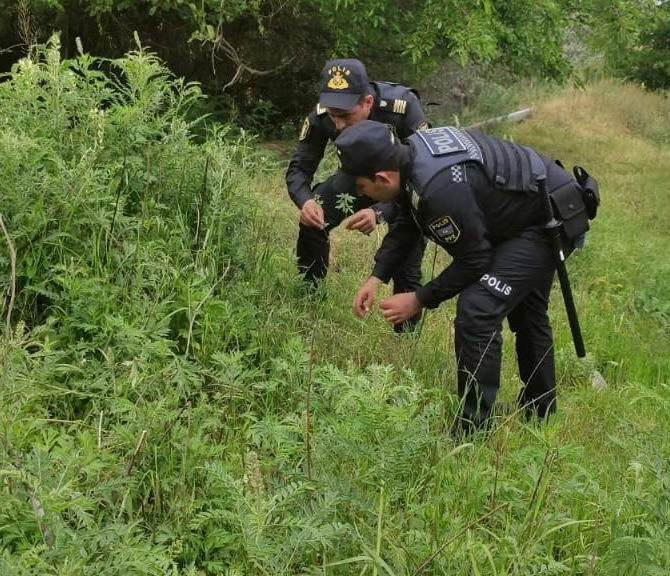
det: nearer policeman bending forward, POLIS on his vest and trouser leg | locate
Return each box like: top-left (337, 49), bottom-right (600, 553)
top-left (335, 121), bottom-right (600, 431)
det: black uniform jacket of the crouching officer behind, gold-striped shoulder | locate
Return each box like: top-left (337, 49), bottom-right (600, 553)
top-left (286, 82), bottom-right (428, 208)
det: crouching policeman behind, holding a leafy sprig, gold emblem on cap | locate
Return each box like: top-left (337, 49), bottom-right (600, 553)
top-left (286, 59), bottom-right (428, 328)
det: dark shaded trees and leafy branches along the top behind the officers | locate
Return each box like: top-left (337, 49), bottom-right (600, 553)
top-left (0, 0), bottom-right (670, 126)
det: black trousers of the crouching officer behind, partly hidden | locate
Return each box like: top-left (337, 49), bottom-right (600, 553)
top-left (296, 172), bottom-right (426, 294)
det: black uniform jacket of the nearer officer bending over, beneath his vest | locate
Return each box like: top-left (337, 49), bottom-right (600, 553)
top-left (373, 131), bottom-right (570, 308)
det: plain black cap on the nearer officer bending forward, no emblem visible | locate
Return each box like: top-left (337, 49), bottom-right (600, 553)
top-left (335, 120), bottom-right (400, 177)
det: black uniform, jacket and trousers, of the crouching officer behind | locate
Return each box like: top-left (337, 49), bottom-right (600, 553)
top-left (286, 82), bottom-right (428, 293)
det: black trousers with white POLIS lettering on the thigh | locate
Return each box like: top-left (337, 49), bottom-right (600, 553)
top-left (455, 226), bottom-right (556, 427)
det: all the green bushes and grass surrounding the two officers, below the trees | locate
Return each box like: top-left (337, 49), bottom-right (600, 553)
top-left (0, 44), bottom-right (670, 576)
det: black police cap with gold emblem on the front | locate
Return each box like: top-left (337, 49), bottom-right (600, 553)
top-left (319, 58), bottom-right (370, 110)
